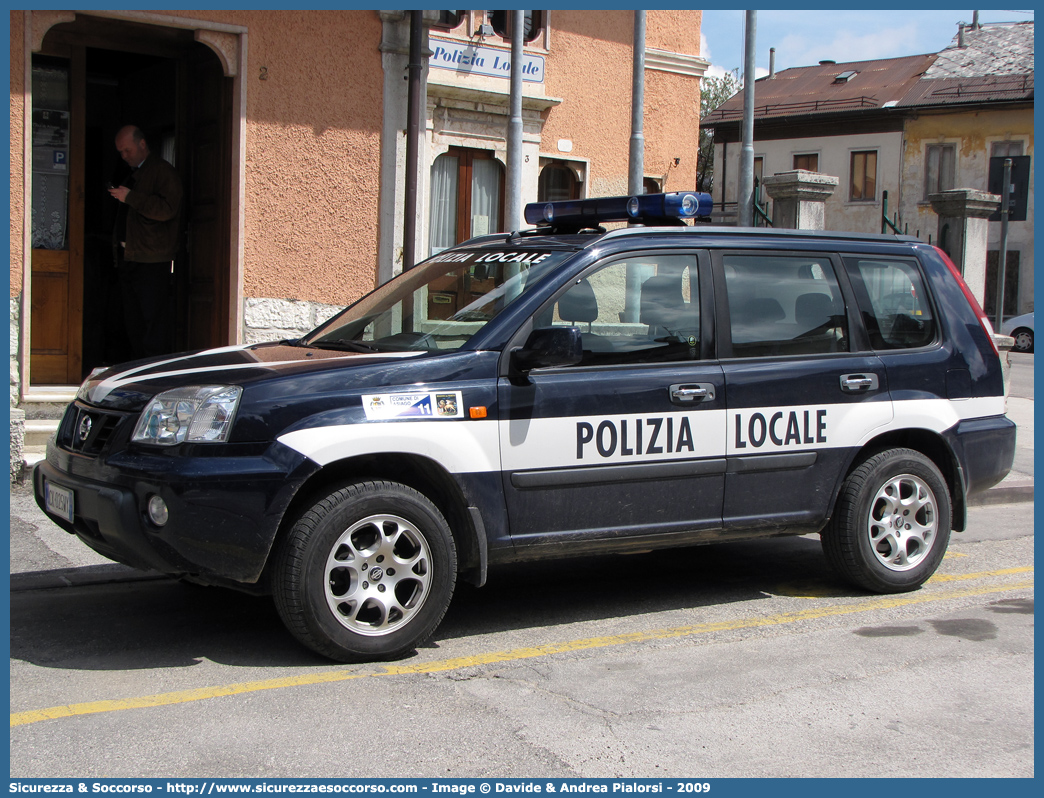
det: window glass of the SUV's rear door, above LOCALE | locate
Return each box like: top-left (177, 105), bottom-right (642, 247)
top-left (722, 254), bottom-right (849, 357)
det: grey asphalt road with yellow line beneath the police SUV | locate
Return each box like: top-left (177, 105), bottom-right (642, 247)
top-left (10, 503), bottom-right (1034, 778)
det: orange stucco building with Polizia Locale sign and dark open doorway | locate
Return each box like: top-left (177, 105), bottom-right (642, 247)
top-left (10, 10), bottom-right (707, 405)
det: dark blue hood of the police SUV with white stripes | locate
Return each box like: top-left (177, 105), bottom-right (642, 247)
top-left (77, 344), bottom-right (425, 410)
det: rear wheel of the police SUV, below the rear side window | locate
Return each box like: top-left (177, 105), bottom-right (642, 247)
top-left (822, 449), bottom-right (952, 593)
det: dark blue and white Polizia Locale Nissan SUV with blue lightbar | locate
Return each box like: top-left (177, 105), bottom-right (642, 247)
top-left (33, 193), bottom-right (1015, 661)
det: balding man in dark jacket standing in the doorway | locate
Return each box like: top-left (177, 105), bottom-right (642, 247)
top-left (109, 125), bottom-right (182, 358)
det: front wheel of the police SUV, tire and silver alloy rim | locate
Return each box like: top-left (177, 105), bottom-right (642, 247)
top-left (272, 482), bottom-right (456, 662)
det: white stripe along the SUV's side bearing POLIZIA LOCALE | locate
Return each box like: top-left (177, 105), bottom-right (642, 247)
top-left (279, 397), bottom-right (1004, 474)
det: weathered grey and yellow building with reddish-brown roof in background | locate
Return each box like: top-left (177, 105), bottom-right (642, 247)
top-left (702, 22), bottom-right (1034, 316)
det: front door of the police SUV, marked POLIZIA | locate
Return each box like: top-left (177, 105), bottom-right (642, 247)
top-left (499, 251), bottom-right (726, 547)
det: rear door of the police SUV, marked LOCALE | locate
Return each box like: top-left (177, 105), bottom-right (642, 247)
top-left (715, 251), bottom-right (892, 532)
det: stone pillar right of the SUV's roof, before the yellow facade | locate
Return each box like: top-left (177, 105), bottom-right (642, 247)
top-left (928, 188), bottom-right (1000, 305)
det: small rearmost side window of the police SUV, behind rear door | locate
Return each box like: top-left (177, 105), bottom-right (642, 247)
top-left (845, 257), bottom-right (935, 349)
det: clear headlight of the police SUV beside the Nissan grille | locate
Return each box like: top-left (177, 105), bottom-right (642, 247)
top-left (133, 385), bottom-right (243, 446)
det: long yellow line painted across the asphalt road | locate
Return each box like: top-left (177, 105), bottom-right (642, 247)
top-left (10, 567), bottom-right (1034, 728)
